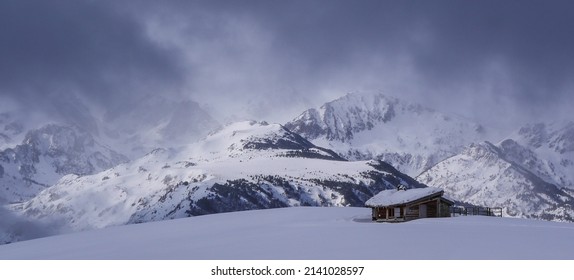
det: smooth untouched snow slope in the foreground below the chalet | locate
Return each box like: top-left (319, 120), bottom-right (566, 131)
top-left (0, 207), bottom-right (574, 259)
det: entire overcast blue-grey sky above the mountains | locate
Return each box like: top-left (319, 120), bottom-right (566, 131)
top-left (0, 0), bottom-right (574, 129)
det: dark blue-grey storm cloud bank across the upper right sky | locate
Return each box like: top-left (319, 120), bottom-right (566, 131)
top-left (261, 1), bottom-right (574, 101)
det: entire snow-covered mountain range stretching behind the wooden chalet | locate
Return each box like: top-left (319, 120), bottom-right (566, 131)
top-left (0, 90), bottom-right (574, 247)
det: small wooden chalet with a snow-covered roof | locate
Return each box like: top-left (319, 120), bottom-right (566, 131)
top-left (365, 187), bottom-right (454, 222)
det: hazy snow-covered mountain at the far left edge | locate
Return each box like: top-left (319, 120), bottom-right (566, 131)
top-left (0, 124), bottom-right (127, 204)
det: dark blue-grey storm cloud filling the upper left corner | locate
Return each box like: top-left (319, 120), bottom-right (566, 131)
top-left (0, 0), bottom-right (181, 114)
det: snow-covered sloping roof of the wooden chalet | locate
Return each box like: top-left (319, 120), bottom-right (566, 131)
top-left (365, 187), bottom-right (449, 207)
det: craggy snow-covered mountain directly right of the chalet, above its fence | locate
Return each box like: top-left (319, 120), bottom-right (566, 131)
top-left (417, 139), bottom-right (574, 222)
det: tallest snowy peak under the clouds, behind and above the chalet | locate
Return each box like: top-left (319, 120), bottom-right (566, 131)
top-left (285, 94), bottom-right (488, 176)
